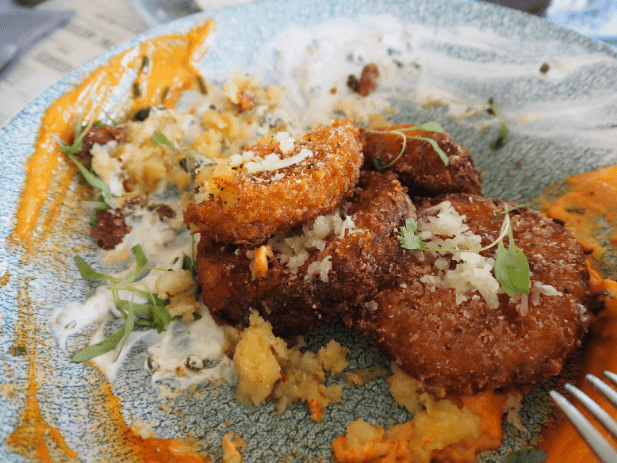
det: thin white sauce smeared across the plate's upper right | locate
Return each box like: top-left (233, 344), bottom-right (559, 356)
top-left (255, 15), bottom-right (617, 154)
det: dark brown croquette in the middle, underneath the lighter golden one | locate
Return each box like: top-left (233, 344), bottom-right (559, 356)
top-left (196, 172), bottom-right (415, 338)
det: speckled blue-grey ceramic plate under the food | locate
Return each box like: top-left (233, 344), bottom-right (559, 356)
top-left (0, 0), bottom-right (617, 462)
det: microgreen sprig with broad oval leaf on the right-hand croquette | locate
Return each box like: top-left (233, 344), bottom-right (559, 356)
top-left (399, 205), bottom-right (530, 298)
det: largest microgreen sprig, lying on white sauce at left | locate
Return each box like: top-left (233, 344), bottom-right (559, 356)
top-left (71, 245), bottom-right (176, 362)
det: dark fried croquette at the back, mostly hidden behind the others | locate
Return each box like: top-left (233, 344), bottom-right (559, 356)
top-left (362, 124), bottom-right (482, 197)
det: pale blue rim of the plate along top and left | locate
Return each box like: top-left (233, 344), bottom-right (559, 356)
top-left (0, 0), bottom-right (617, 461)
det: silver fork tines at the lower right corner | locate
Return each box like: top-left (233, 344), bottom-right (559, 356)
top-left (550, 371), bottom-right (617, 463)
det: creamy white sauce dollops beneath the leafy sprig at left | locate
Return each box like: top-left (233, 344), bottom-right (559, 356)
top-left (51, 219), bottom-right (234, 389)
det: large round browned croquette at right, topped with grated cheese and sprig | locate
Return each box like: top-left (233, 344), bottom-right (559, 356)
top-left (356, 194), bottom-right (590, 393)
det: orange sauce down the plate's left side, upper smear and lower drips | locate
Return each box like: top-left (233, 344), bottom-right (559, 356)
top-left (6, 20), bottom-right (214, 463)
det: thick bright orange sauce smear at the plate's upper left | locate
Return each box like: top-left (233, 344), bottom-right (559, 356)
top-left (11, 20), bottom-right (214, 245)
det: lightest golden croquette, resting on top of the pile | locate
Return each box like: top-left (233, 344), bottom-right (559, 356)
top-left (184, 120), bottom-right (363, 245)
